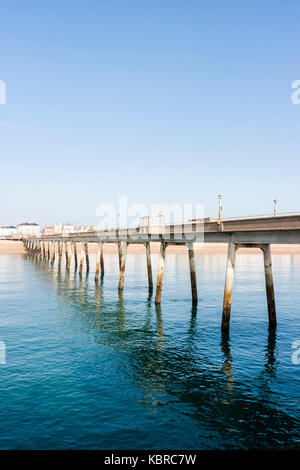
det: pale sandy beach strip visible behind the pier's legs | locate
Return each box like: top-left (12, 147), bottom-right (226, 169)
top-left (0, 240), bottom-right (300, 255)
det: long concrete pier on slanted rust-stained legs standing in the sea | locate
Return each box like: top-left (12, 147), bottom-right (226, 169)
top-left (23, 215), bottom-right (300, 331)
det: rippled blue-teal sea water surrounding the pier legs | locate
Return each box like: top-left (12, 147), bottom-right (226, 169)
top-left (0, 254), bottom-right (300, 449)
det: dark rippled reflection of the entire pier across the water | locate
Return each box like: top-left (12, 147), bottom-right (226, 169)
top-left (26, 253), bottom-right (297, 446)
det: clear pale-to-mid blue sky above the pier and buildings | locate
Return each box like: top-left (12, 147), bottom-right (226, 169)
top-left (0, 0), bottom-right (300, 225)
